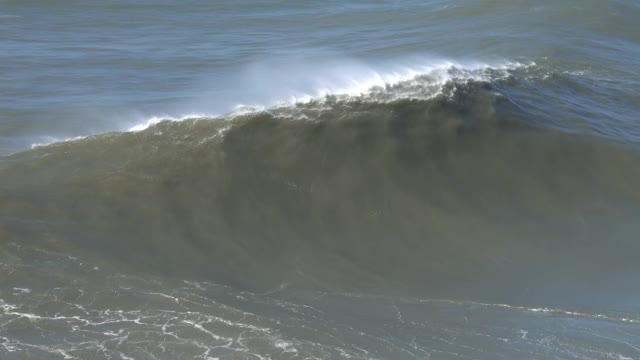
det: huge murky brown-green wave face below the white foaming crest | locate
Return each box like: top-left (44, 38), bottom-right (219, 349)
top-left (0, 69), bottom-right (640, 305)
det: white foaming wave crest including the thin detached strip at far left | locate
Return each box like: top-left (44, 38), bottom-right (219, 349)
top-left (5, 60), bottom-right (536, 152)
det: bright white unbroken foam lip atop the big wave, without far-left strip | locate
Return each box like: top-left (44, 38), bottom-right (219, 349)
top-left (122, 61), bottom-right (536, 132)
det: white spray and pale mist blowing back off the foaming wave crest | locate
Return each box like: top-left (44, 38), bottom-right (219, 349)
top-left (25, 55), bottom-right (535, 143)
